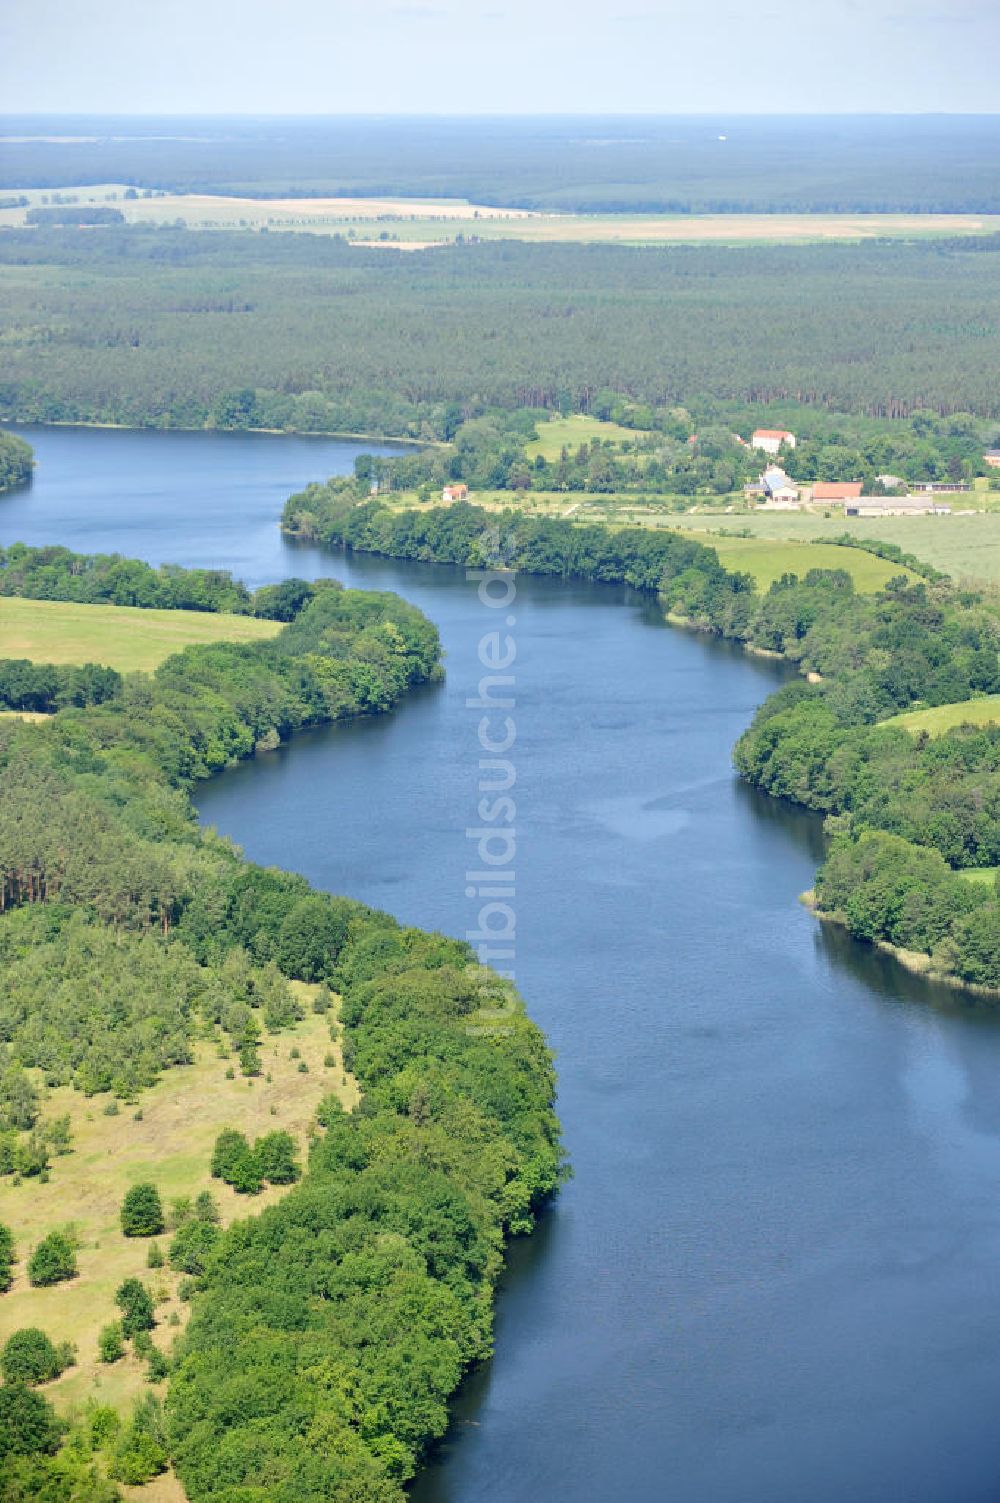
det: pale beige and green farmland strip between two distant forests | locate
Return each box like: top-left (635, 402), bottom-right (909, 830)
top-left (0, 183), bottom-right (1000, 249)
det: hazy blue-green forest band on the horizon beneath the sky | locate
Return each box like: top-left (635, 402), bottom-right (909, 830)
top-left (0, 114), bottom-right (1000, 213)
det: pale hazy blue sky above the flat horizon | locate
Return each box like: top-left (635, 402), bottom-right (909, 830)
top-left (0, 0), bottom-right (1000, 114)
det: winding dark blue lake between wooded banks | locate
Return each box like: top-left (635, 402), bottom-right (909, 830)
top-left (0, 428), bottom-right (1000, 1503)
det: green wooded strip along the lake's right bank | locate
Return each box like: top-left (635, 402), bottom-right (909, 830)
top-left (283, 481), bottom-right (1000, 989)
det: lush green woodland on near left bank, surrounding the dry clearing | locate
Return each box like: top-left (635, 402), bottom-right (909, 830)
top-left (0, 559), bottom-right (561, 1503)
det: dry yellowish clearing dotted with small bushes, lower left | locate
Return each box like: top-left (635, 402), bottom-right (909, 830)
top-left (0, 983), bottom-right (358, 1430)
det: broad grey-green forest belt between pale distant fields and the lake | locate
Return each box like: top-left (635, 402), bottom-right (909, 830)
top-left (0, 227), bottom-right (1000, 439)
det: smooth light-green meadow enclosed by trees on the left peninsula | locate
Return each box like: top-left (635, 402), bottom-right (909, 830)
top-left (0, 595), bottom-right (281, 672)
